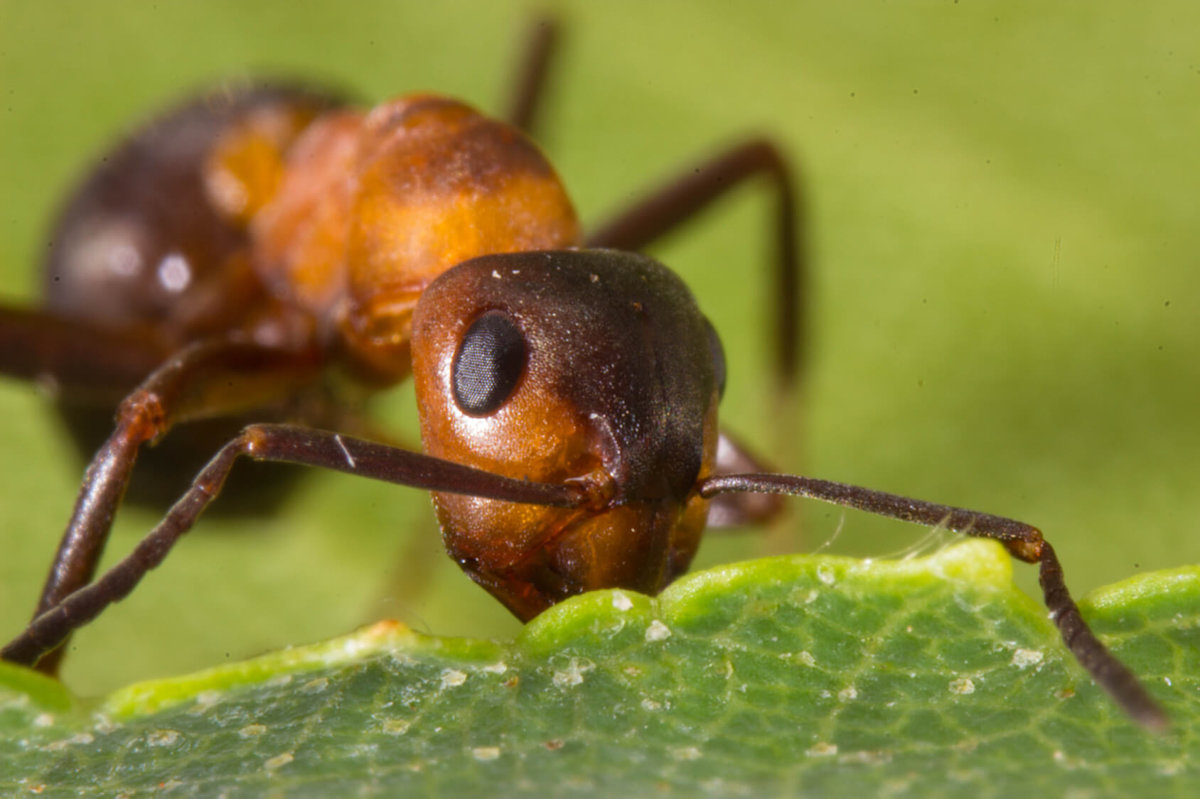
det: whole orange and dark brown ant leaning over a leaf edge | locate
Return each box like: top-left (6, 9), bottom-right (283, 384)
top-left (0, 24), bottom-right (1166, 728)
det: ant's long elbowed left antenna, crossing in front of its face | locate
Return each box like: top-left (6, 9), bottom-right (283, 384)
top-left (0, 425), bottom-right (588, 665)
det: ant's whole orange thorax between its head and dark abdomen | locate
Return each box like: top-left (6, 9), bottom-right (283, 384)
top-left (222, 95), bottom-right (580, 382)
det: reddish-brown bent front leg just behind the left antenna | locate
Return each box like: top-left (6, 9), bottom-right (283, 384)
top-left (34, 340), bottom-right (319, 674)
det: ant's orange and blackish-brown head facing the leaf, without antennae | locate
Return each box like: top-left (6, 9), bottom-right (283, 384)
top-left (413, 251), bottom-right (724, 618)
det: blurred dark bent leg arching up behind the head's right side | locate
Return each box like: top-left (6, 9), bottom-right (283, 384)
top-left (587, 139), bottom-right (808, 385)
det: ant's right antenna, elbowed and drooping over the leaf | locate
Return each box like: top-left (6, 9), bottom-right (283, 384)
top-left (698, 474), bottom-right (1168, 729)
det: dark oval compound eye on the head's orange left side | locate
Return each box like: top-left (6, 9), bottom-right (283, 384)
top-left (451, 311), bottom-right (527, 416)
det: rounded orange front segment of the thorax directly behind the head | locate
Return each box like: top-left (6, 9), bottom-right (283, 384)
top-left (343, 95), bottom-right (580, 379)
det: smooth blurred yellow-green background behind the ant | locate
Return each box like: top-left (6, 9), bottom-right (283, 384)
top-left (0, 0), bottom-right (1200, 693)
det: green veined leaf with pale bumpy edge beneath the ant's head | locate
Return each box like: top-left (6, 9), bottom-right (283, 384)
top-left (0, 541), bottom-right (1200, 797)
